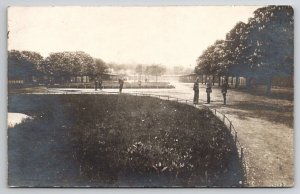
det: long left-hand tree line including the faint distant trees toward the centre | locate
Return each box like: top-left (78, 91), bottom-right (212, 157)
top-left (8, 50), bottom-right (166, 83)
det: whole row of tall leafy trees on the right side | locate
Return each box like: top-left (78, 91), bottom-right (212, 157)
top-left (195, 6), bottom-right (294, 93)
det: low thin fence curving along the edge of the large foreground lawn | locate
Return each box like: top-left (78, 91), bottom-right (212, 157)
top-left (35, 90), bottom-right (247, 186)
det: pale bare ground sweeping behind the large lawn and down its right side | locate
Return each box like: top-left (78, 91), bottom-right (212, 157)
top-left (11, 82), bottom-right (294, 187)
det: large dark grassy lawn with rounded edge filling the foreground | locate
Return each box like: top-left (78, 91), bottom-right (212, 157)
top-left (8, 94), bottom-right (243, 187)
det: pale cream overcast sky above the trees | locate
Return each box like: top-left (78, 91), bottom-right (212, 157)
top-left (8, 6), bottom-right (258, 67)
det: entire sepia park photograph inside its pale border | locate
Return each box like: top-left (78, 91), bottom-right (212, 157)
top-left (7, 5), bottom-right (295, 188)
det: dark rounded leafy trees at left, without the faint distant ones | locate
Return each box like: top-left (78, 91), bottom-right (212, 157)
top-left (8, 50), bottom-right (108, 81)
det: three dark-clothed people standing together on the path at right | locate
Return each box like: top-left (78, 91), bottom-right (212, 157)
top-left (193, 78), bottom-right (228, 105)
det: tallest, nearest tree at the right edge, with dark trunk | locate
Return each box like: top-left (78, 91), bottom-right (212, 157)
top-left (249, 6), bottom-right (294, 93)
